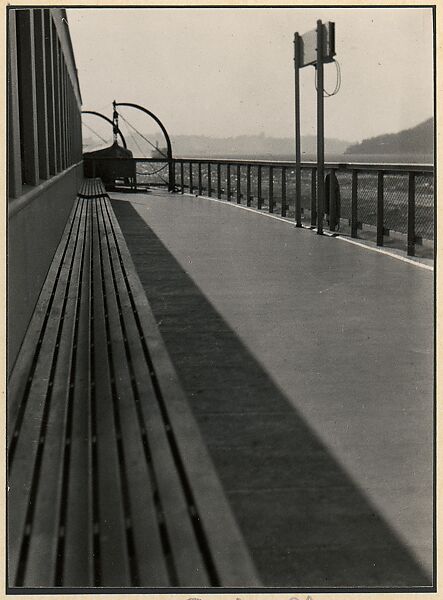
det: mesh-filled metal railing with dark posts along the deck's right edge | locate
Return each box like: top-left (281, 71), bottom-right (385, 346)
top-left (174, 158), bottom-right (434, 256)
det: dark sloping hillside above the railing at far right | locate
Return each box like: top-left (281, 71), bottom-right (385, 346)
top-left (345, 118), bottom-right (434, 155)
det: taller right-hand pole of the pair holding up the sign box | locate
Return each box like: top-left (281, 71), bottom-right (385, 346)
top-left (317, 20), bottom-right (325, 235)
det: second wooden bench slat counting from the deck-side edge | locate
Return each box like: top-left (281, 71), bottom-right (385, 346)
top-left (103, 201), bottom-right (209, 586)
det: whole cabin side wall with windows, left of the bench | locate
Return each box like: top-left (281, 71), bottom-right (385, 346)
top-left (7, 8), bottom-right (83, 371)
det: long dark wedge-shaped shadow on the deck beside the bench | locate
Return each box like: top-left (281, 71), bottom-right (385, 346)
top-left (112, 200), bottom-right (432, 588)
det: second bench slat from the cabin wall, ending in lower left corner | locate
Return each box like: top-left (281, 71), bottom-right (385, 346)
top-left (8, 199), bottom-right (86, 581)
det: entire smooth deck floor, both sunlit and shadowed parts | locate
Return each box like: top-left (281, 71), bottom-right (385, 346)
top-left (111, 193), bottom-right (434, 587)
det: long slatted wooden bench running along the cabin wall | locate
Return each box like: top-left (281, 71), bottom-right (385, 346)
top-left (7, 180), bottom-right (260, 588)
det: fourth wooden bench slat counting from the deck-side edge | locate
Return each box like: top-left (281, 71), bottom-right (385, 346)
top-left (93, 203), bottom-right (131, 587)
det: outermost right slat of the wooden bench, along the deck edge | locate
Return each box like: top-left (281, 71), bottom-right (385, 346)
top-left (107, 201), bottom-right (260, 587)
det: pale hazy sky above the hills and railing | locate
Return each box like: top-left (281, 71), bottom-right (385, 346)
top-left (68, 8), bottom-right (433, 141)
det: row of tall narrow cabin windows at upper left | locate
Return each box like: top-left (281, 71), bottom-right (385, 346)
top-left (8, 9), bottom-right (82, 197)
